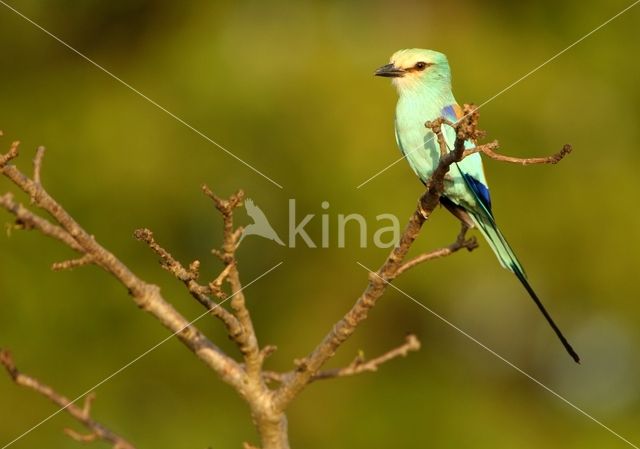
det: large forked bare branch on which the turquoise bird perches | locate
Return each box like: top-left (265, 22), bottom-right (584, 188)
top-left (0, 105), bottom-right (571, 449)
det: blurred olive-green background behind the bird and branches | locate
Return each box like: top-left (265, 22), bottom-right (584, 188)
top-left (0, 0), bottom-right (640, 449)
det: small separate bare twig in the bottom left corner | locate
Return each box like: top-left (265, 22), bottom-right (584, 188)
top-left (0, 349), bottom-right (135, 449)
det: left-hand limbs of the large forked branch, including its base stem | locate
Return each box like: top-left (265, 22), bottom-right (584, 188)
top-left (0, 144), bottom-right (289, 449)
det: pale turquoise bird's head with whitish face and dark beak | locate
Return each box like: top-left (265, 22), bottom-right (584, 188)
top-left (374, 48), bottom-right (451, 93)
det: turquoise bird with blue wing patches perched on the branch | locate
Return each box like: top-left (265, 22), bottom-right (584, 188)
top-left (375, 48), bottom-right (580, 363)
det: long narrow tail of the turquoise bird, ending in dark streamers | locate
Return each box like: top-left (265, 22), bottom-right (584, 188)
top-left (470, 210), bottom-right (580, 363)
